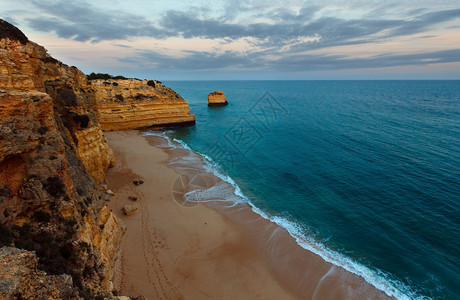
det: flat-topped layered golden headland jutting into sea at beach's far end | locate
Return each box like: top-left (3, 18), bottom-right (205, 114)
top-left (91, 79), bottom-right (195, 131)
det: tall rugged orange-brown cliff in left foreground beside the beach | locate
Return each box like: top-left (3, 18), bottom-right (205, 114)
top-left (0, 20), bottom-right (124, 297)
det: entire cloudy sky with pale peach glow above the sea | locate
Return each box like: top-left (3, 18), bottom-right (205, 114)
top-left (0, 0), bottom-right (460, 80)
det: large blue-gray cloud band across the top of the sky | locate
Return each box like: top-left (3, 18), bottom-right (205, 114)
top-left (23, 0), bottom-right (460, 51)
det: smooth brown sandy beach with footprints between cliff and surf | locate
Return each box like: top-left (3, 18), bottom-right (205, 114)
top-left (106, 131), bottom-right (390, 299)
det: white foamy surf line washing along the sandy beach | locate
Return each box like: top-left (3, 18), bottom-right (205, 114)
top-left (144, 131), bottom-right (431, 300)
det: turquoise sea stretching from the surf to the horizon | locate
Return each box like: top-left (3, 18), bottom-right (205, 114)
top-left (161, 81), bottom-right (460, 299)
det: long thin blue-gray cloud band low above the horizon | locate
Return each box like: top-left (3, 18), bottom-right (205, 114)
top-left (119, 49), bottom-right (460, 71)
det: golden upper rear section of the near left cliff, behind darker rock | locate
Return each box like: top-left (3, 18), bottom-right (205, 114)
top-left (0, 28), bottom-right (114, 183)
